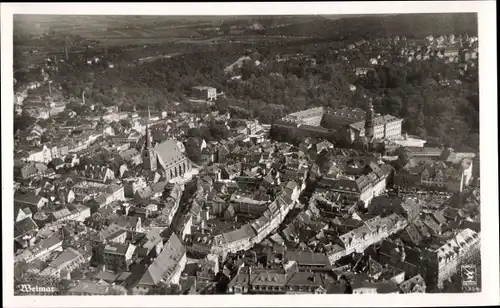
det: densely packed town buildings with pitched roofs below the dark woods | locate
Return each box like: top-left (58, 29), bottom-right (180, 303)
top-left (14, 32), bottom-right (480, 295)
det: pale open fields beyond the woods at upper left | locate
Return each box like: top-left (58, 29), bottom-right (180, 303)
top-left (14, 15), bottom-right (320, 44)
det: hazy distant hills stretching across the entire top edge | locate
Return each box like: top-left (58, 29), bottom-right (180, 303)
top-left (14, 13), bottom-right (477, 37)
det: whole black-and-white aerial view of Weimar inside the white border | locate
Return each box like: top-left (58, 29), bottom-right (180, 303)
top-left (11, 13), bottom-right (480, 298)
